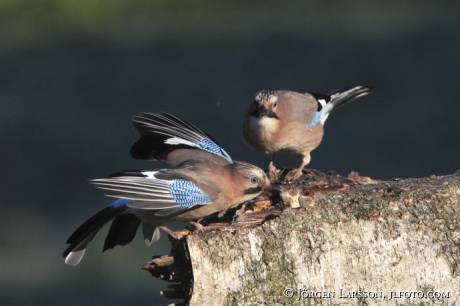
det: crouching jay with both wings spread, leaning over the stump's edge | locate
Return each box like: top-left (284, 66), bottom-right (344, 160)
top-left (62, 113), bottom-right (280, 265)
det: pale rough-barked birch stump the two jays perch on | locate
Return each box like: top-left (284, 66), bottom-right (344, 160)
top-left (145, 174), bottom-right (460, 305)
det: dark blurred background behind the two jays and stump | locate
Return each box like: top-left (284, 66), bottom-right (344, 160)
top-left (0, 0), bottom-right (460, 305)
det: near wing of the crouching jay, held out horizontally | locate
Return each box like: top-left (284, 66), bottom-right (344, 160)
top-left (90, 170), bottom-right (212, 209)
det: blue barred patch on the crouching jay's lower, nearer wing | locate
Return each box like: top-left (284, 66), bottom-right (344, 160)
top-left (169, 180), bottom-right (211, 207)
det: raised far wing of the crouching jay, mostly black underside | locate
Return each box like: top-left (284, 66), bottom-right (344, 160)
top-left (131, 113), bottom-right (233, 164)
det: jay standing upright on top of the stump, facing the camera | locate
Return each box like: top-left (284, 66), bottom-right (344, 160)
top-left (243, 86), bottom-right (373, 180)
